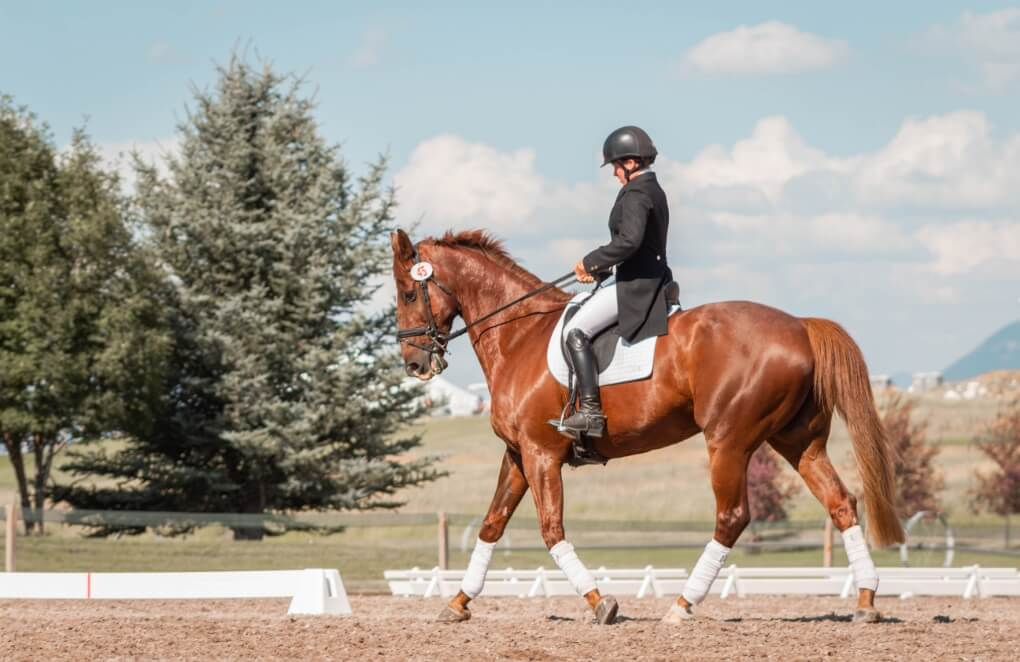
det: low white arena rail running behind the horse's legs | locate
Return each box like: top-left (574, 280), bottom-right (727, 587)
top-left (384, 565), bottom-right (1020, 599)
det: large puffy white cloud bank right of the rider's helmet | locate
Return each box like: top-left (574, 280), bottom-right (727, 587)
top-left (659, 111), bottom-right (1020, 210)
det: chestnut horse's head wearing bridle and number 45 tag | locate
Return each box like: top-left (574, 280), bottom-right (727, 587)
top-left (390, 230), bottom-right (458, 381)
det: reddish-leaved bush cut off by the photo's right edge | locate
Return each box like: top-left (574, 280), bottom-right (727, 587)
top-left (971, 402), bottom-right (1020, 515)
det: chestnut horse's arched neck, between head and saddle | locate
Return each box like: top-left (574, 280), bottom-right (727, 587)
top-left (436, 249), bottom-right (568, 391)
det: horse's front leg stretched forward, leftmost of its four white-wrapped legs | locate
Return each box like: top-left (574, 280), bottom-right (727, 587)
top-left (439, 449), bottom-right (527, 622)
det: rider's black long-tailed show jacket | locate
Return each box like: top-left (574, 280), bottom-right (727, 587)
top-left (583, 172), bottom-right (673, 343)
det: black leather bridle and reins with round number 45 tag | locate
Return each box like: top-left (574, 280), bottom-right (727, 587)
top-left (397, 246), bottom-right (575, 374)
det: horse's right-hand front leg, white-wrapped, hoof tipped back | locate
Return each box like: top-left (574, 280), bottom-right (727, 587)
top-left (523, 450), bottom-right (619, 625)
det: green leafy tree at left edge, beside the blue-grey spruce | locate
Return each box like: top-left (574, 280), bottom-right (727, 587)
top-left (0, 99), bottom-right (168, 529)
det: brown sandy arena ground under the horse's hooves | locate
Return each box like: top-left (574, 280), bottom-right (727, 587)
top-left (0, 596), bottom-right (1020, 660)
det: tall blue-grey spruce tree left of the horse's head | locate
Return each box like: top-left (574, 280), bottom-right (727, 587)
top-left (55, 55), bottom-right (439, 538)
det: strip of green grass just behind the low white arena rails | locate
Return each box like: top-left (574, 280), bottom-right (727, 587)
top-left (3, 527), bottom-right (1018, 591)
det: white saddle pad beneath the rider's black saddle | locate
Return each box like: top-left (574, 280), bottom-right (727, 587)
top-left (546, 282), bottom-right (681, 388)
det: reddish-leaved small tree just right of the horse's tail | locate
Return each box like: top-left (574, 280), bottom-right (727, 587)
top-left (881, 394), bottom-right (945, 519)
